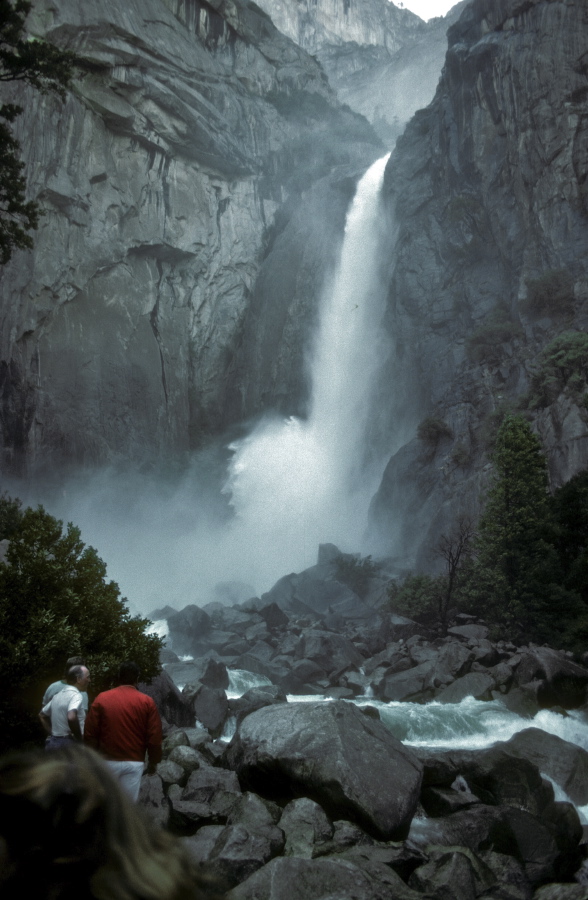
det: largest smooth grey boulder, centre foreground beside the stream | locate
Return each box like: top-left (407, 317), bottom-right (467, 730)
top-left (226, 701), bottom-right (422, 840)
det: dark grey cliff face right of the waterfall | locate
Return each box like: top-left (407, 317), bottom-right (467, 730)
top-left (372, 0), bottom-right (588, 565)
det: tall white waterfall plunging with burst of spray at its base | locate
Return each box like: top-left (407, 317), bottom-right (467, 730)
top-left (226, 156), bottom-right (388, 590)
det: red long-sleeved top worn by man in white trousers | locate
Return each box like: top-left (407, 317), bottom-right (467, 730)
top-left (84, 684), bottom-right (162, 764)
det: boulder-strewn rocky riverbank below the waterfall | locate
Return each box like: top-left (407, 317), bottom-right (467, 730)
top-left (142, 545), bottom-right (588, 900)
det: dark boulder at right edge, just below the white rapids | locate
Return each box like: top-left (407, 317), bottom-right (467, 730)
top-left (500, 728), bottom-right (588, 806)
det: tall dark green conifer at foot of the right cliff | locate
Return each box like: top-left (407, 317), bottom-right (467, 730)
top-left (468, 415), bottom-right (581, 643)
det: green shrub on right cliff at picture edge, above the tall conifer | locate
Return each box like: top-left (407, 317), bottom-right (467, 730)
top-left (529, 331), bottom-right (588, 408)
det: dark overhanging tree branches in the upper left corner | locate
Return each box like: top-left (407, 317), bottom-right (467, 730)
top-left (0, 0), bottom-right (77, 265)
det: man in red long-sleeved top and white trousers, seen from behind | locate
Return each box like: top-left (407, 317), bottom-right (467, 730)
top-left (84, 662), bottom-right (162, 800)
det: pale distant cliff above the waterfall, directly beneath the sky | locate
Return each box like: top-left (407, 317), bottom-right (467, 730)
top-left (259, 0), bottom-right (465, 146)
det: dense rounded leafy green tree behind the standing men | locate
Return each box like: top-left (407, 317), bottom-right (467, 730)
top-left (0, 495), bottom-right (162, 748)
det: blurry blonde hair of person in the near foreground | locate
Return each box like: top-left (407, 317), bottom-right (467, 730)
top-left (0, 745), bottom-right (217, 900)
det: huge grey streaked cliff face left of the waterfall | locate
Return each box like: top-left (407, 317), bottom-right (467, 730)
top-left (0, 0), bottom-right (381, 474)
